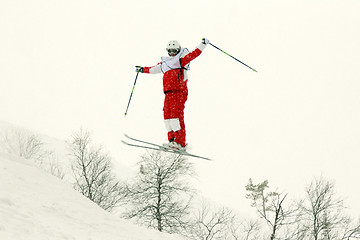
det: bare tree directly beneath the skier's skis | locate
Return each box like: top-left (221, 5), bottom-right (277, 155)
top-left (126, 151), bottom-right (194, 233)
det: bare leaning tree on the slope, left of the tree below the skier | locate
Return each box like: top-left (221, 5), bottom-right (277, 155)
top-left (69, 129), bottom-right (125, 211)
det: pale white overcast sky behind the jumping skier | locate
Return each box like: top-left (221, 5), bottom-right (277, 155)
top-left (0, 0), bottom-right (360, 216)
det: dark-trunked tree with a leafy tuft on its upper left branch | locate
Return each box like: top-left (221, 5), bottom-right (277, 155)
top-left (246, 179), bottom-right (298, 240)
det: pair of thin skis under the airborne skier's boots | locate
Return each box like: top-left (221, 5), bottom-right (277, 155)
top-left (121, 134), bottom-right (211, 160)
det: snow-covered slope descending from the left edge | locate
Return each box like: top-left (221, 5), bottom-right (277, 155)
top-left (0, 153), bottom-right (184, 240)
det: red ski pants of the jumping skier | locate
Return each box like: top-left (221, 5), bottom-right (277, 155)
top-left (164, 91), bottom-right (187, 147)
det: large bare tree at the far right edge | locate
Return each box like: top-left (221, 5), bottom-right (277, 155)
top-left (301, 177), bottom-right (360, 240)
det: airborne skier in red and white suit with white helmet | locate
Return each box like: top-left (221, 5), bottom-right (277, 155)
top-left (136, 38), bottom-right (209, 151)
